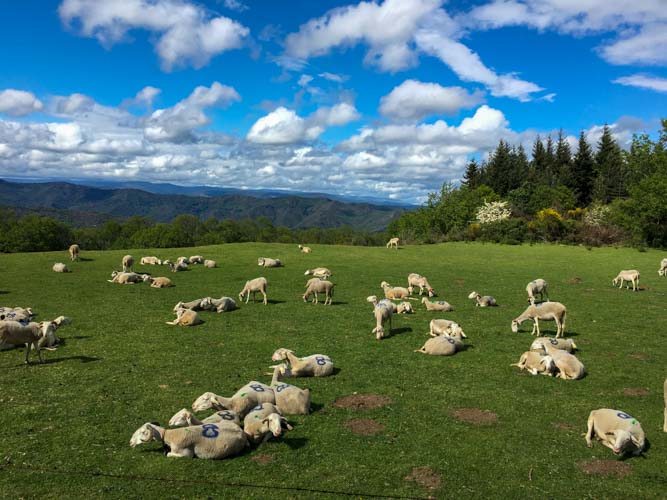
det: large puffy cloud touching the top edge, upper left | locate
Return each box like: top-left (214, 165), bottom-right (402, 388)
top-left (58, 0), bottom-right (250, 71)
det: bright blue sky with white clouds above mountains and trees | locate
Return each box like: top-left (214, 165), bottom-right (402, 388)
top-left (0, 0), bottom-right (667, 202)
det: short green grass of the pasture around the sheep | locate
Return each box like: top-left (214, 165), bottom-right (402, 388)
top-left (0, 243), bottom-right (667, 498)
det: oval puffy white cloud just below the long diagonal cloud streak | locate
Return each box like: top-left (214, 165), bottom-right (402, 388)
top-left (380, 80), bottom-right (482, 120)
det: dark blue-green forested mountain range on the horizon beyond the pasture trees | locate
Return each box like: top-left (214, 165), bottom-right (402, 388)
top-left (0, 180), bottom-right (407, 232)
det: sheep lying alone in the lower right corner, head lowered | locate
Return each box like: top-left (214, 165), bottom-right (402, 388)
top-left (586, 408), bottom-right (646, 456)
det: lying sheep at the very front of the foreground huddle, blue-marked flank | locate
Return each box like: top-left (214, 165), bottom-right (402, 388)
top-left (130, 423), bottom-right (248, 459)
